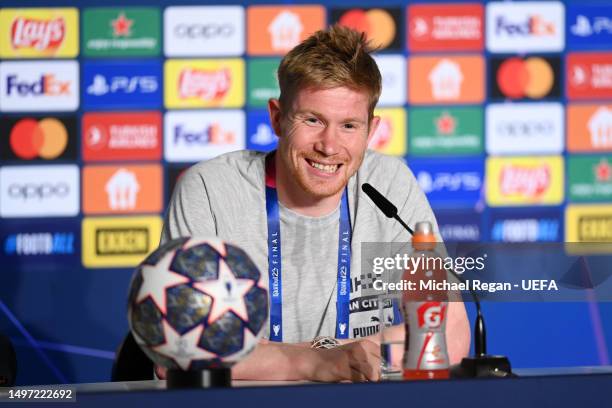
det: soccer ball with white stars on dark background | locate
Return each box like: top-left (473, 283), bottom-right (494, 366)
top-left (128, 238), bottom-right (268, 371)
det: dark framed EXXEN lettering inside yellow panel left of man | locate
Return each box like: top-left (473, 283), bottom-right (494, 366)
top-left (96, 228), bottom-right (151, 256)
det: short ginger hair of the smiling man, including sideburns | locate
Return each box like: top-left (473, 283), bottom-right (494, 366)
top-left (278, 24), bottom-right (382, 119)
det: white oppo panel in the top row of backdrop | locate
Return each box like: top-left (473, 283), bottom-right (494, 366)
top-left (164, 6), bottom-right (245, 57)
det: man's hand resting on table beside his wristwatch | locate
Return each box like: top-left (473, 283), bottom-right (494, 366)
top-left (305, 340), bottom-right (380, 382)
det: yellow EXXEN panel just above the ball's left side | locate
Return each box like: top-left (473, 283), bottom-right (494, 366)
top-left (82, 216), bottom-right (162, 268)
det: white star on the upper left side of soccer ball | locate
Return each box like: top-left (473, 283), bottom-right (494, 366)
top-left (136, 252), bottom-right (189, 315)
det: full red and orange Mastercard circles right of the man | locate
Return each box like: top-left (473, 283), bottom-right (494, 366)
top-left (497, 57), bottom-right (555, 99)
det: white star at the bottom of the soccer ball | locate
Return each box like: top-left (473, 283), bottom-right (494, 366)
top-left (152, 320), bottom-right (217, 371)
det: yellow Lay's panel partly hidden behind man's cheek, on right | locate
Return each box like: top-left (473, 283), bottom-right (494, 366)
top-left (368, 108), bottom-right (407, 156)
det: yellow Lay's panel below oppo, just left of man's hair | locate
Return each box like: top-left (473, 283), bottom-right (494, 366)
top-left (164, 58), bottom-right (245, 108)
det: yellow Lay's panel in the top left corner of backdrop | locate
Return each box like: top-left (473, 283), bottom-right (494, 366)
top-left (0, 8), bottom-right (79, 58)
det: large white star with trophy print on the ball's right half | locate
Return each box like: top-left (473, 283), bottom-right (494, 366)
top-left (193, 259), bottom-right (255, 324)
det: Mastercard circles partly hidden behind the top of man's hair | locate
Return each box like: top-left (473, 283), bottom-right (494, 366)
top-left (338, 8), bottom-right (397, 48)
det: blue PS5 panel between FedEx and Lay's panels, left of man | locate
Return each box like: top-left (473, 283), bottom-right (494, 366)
top-left (83, 61), bottom-right (162, 109)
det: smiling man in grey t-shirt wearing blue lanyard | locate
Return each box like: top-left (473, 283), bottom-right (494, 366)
top-left (162, 26), bottom-right (469, 381)
